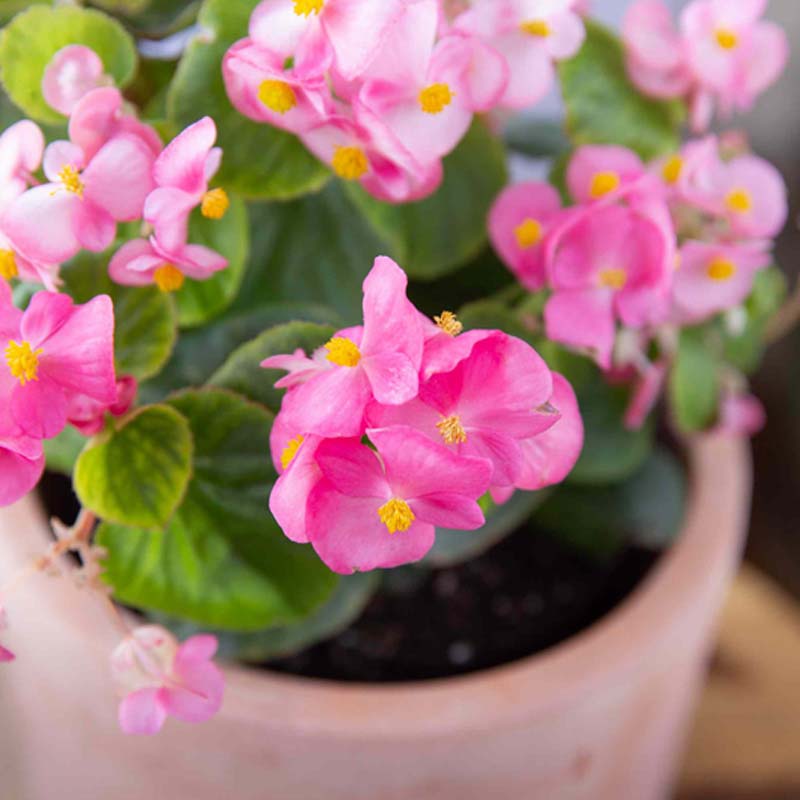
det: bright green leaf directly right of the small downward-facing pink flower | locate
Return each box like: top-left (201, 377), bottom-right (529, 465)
top-left (175, 192), bottom-right (250, 327)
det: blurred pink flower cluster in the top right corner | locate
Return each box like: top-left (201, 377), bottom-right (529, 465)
top-left (623, 0), bottom-right (789, 132)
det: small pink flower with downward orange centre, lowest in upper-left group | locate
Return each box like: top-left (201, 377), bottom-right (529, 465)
top-left (108, 236), bottom-right (228, 292)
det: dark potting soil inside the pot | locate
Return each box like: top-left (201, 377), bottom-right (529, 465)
top-left (42, 474), bottom-right (658, 682)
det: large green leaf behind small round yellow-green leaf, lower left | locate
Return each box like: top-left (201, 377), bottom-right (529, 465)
top-left (98, 389), bottom-right (337, 631)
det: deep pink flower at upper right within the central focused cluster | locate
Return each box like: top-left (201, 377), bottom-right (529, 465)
top-left (367, 331), bottom-right (559, 486)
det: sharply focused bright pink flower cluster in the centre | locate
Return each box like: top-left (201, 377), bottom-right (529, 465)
top-left (262, 257), bottom-right (583, 573)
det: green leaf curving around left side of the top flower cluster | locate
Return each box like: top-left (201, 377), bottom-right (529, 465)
top-left (167, 0), bottom-right (330, 199)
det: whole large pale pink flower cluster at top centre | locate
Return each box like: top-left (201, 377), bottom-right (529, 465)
top-left (223, 0), bottom-right (584, 202)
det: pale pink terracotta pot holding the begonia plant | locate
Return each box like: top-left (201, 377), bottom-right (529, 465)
top-left (0, 437), bottom-right (750, 800)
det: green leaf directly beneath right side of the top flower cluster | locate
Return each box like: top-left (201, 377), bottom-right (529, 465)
top-left (346, 120), bottom-right (507, 280)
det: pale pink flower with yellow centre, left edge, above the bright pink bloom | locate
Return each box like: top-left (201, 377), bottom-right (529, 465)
top-left (3, 134), bottom-right (153, 264)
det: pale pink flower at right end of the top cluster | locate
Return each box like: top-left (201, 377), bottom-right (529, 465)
top-left (454, 0), bottom-right (586, 109)
